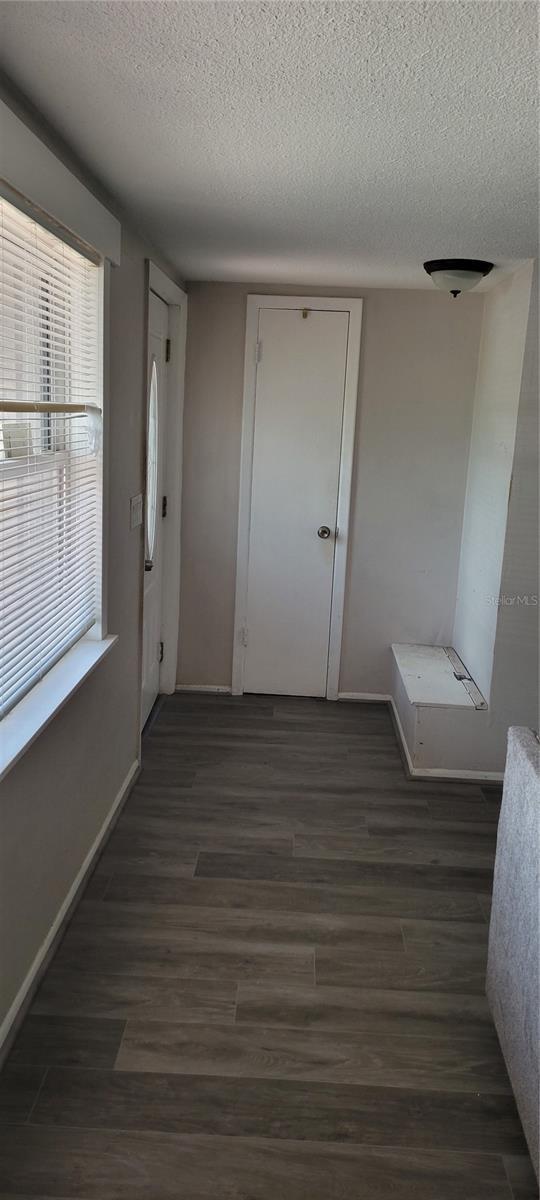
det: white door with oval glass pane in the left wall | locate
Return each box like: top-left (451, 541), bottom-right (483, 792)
top-left (142, 293), bottom-right (169, 726)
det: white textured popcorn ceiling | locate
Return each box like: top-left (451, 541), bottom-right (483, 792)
top-left (0, 0), bottom-right (538, 287)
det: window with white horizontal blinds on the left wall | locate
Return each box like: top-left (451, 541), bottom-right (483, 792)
top-left (0, 199), bottom-right (102, 718)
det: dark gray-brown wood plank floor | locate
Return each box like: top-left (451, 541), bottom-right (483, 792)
top-left (0, 694), bottom-right (538, 1200)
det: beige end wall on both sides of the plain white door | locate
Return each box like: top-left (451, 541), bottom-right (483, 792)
top-left (178, 283), bottom-right (482, 692)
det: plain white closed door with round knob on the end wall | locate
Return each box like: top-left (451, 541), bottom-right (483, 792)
top-left (244, 307), bottom-right (349, 696)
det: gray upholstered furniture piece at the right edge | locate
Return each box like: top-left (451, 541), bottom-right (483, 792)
top-left (487, 727), bottom-right (540, 1175)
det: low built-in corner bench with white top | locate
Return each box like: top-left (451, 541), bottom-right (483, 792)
top-left (392, 644), bottom-right (487, 775)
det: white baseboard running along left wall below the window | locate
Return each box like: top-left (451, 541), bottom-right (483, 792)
top-left (0, 761), bottom-right (140, 1057)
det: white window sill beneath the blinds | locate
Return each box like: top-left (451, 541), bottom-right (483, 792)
top-left (0, 635), bottom-right (118, 780)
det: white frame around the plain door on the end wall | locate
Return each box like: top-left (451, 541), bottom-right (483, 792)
top-left (232, 295), bottom-right (362, 700)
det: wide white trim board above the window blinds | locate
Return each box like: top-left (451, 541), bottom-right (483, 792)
top-left (0, 101), bottom-right (121, 264)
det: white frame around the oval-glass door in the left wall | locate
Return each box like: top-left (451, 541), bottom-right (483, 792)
top-left (139, 259), bottom-right (187, 695)
